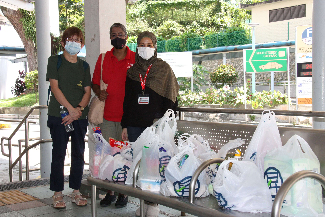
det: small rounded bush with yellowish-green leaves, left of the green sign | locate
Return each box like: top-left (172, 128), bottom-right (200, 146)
top-left (210, 64), bottom-right (238, 88)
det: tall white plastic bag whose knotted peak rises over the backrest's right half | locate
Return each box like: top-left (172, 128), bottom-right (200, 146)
top-left (243, 111), bottom-right (282, 173)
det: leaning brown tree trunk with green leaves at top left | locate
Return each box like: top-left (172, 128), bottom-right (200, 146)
top-left (1, 6), bottom-right (37, 71)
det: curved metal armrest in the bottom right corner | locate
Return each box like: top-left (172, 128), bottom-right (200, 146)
top-left (271, 170), bottom-right (325, 217)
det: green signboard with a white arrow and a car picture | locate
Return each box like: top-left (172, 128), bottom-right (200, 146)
top-left (245, 48), bottom-right (288, 72)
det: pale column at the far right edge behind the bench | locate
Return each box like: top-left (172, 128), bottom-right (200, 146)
top-left (312, 0), bottom-right (325, 129)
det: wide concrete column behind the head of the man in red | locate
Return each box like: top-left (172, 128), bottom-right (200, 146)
top-left (85, 0), bottom-right (126, 74)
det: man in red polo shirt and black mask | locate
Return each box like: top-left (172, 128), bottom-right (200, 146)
top-left (92, 23), bottom-right (135, 208)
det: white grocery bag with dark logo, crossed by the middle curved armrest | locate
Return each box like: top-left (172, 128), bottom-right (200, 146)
top-left (160, 146), bottom-right (209, 197)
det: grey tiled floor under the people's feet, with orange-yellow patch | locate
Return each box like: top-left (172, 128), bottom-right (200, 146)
top-left (0, 183), bottom-right (193, 217)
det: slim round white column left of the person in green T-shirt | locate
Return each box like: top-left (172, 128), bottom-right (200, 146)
top-left (35, 0), bottom-right (52, 178)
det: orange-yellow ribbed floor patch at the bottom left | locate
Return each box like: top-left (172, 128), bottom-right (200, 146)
top-left (0, 190), bottom-right (37, 206)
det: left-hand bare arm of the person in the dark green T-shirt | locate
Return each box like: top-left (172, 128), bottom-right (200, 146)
top-left (49, 78), bottom-right (82, 125)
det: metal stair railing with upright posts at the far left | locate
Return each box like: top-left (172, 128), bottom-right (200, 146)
top-left (1, 105), bottom-right (47, 182)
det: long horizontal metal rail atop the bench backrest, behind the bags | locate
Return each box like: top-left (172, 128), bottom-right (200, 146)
top-left (176, 107), bottom-right (325, 117)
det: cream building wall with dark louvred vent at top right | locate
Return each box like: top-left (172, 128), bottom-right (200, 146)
top-left (251, 0), bottom-right (313, 43)
